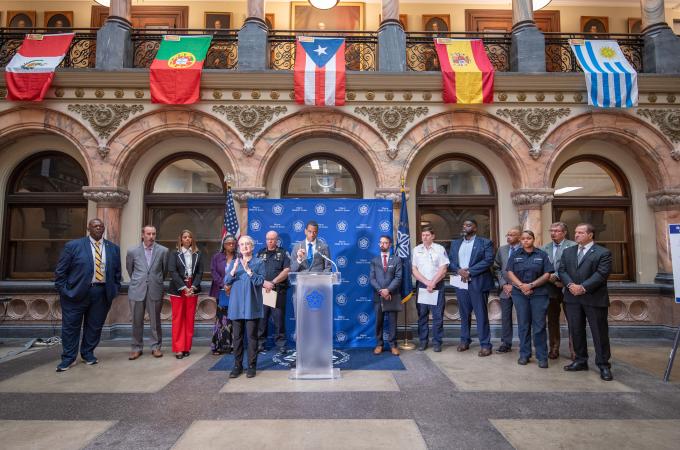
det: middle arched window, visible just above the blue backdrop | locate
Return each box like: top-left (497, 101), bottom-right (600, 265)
top-left (281, 153), bottom-right (363, 198)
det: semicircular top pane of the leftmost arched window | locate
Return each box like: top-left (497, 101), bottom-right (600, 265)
top-left (12, 155), bottom-right (87, 193)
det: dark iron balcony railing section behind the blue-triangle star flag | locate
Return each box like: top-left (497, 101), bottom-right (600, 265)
top-left (269, 30), bottom-right (378, 71)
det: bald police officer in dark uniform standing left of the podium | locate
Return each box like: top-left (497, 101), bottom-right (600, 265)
top-left (257, 231), bottom-right (290, 352)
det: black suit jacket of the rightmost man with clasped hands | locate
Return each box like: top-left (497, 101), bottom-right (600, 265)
top-left (559, 244), bottom-right (612, 308)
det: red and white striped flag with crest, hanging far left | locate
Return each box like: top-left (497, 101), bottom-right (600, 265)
top-left (5, 33), bottom-right (74, 102)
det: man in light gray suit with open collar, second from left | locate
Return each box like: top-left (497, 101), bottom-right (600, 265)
top-left (125, 225), bottom-right (168, 360)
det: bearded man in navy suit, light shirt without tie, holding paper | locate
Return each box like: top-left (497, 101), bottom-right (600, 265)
top-left (449, 219), bottom-right (493, 356)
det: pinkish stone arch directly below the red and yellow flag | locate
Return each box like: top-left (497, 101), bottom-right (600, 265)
top-left (397, 110), bottom-right (532, 189)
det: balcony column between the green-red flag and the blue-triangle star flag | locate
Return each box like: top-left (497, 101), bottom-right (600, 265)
top-left (238, 0), bottom-right (269, 70)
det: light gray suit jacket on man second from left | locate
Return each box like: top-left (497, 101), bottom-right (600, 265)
top-left (125, 243), bottom-right (168, 302)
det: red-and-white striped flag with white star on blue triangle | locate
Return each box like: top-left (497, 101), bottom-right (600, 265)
top-left (295, 36), bottom-right (345, 106)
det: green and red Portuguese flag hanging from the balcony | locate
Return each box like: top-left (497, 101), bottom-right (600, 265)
top-left (150, 35), bottom-right (212, 105)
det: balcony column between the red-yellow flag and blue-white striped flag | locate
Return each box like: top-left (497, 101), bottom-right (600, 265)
top-left (510, 0), bottom-right (545, 73)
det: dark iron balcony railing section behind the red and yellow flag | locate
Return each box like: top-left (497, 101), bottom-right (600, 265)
top-left (406, 32), bottom-right (510, 72)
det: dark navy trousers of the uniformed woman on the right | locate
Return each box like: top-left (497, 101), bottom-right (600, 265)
top-left (512, 289), bottom-right (548, 361)
